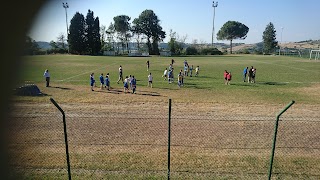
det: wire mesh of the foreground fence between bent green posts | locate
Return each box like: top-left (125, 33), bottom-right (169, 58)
top-left (9, 99), bottom-right (320, 179)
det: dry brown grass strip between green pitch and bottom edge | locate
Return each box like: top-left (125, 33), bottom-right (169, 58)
top-left (8, 83), bottom-right (320, 179)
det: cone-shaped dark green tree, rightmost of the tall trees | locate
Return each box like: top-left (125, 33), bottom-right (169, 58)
top-left (262, 22), bottom-right (278, 53)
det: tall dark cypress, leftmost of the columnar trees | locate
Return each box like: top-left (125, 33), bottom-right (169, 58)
top-left (68, 12), bottom-right (86, 54)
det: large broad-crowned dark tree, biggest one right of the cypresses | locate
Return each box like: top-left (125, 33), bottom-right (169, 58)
top-left (133, 9), bottom-right (166, 55)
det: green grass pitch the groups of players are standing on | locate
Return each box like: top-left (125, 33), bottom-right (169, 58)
top-left (19, 55), bottom-right (320, 104)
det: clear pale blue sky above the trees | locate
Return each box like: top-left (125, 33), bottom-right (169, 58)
top-left (28, 0), bottom-right (320, 44)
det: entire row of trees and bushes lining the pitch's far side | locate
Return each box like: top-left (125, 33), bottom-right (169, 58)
top-left (25, 9), bottom-right (278, 55)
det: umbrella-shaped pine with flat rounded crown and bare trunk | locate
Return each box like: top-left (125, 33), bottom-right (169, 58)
top-left (217, 21), bottom-right (249, 54)
